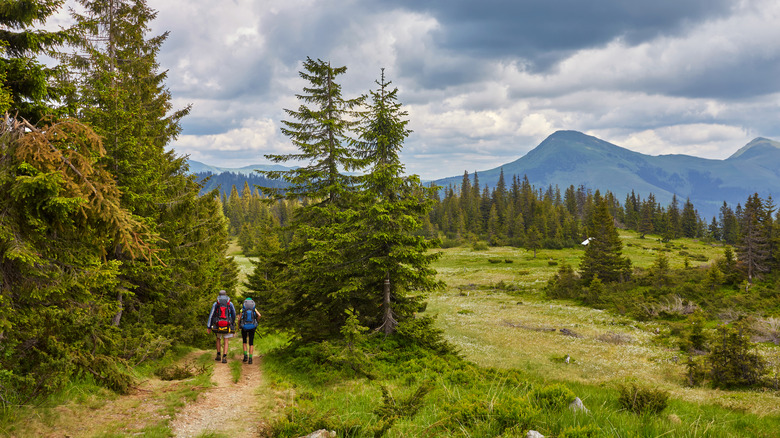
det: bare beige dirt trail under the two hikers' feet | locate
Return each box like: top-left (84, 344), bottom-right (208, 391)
top-left (170, 352), bottom-right (263, 438)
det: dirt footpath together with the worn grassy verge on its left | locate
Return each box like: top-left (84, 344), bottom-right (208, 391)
top-left (11, 338), bottom-right (274, 438)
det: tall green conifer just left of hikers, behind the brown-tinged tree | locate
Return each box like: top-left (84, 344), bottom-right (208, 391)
top-left (64, 0), bottom-right (236, 339)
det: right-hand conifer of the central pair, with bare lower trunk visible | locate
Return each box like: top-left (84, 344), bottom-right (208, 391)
top-left (350, 69), bottom-right (442, 334)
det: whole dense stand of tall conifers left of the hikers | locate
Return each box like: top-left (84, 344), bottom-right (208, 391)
top-left (0, 0), bottom-right (237, 411)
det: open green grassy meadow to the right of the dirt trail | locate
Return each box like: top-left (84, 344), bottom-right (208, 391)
top-left (251, 232), bottom-right (780, 437)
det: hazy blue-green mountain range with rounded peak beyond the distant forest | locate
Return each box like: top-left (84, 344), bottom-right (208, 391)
top-left (435, 131), bottom-right (780, 220)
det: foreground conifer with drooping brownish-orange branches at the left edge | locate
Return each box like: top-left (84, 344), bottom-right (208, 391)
top-left (0, 117), bottom-right (156, 398)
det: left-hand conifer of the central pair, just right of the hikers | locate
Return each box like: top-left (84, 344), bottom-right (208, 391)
top-left (250, 58), bottom-right (365, 339)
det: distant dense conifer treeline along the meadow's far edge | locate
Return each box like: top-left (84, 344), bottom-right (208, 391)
top-left (222, 168), bottom-right (748, 253)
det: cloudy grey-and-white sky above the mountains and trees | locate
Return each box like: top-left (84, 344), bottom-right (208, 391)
top-left (58, 0), bottom-right (780, 179)
